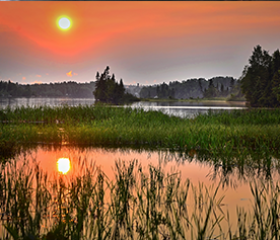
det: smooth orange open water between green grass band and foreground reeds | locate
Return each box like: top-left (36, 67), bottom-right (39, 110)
top-left (14, 146), bottom-right (280, 218)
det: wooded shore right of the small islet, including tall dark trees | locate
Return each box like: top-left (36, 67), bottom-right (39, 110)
top-left (140, 45), bottom-right (280, 107)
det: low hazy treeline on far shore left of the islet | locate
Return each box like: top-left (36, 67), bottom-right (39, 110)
top-left (0, 81), bottom-right (95, 98)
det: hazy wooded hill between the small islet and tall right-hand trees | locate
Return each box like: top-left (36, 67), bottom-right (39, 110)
top-left (140, 77), bottom-right (243, 99)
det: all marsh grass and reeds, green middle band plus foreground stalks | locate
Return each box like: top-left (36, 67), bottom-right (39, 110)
top-left (0, 105), bottom-right (280, 239)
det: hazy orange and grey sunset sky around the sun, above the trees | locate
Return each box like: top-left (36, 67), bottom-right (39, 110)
top-left (0, 1), bottom-right (280, 84)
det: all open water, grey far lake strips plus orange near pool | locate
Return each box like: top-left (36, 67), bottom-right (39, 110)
top-left (0, 98), bottom-right (264, 236)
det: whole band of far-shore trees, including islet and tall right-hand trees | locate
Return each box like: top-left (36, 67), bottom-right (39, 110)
top-left (0, 45), bottom-right (280, 107)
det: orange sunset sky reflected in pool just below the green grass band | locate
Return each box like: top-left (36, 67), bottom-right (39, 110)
top-left (4, 145), bottom-right (279, 232)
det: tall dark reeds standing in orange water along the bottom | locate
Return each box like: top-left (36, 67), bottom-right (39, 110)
top-left (0, 159), bottom-right (280, 240)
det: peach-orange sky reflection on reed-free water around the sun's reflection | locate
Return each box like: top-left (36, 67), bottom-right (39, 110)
top-left (15, 146), bottom-right (279, 214)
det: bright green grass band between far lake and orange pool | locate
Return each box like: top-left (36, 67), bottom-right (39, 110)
top-left (0, 106), bottom-right (280, 152)
